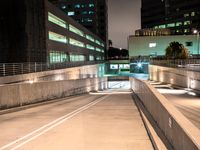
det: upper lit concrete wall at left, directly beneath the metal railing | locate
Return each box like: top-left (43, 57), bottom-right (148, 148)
top-left (0, 64), bottom-right (101, 84)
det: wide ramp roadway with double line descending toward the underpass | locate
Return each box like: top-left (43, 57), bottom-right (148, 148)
top-left (0, 83), bottom-right (153, 150)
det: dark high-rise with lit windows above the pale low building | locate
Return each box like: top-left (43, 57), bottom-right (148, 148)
top-left (141, 0), bottom-right (200, 35)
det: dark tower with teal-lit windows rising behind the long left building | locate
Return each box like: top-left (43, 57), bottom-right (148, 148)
top-left (49, 0), bottom-right (108, 46)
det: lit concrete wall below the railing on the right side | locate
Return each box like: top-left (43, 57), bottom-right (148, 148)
top-left (149, 65), bottom-right (200, 90)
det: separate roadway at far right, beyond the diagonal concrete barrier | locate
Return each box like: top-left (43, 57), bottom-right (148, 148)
top-left (151, 82), bottom-right (200, 129)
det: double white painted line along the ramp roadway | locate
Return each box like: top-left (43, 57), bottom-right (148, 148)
top-left (0, 95), bottom-right (108, 150)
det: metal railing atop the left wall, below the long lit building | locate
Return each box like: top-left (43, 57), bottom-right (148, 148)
top-left (0, 61), bottom-right (104, 77)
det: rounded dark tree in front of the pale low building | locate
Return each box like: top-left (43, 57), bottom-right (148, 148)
top-left (165, 41), bottom-right (188, 59)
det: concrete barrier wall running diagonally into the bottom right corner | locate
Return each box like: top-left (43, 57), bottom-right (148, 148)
top-left (130, 78), bottom-right (200, 150)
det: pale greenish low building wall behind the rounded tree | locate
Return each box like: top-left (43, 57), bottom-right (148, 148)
top-left (128, 35), bottom-right (200, 59)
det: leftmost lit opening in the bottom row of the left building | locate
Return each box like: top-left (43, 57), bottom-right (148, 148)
top-left (49, 51), bottom-right (68, 63)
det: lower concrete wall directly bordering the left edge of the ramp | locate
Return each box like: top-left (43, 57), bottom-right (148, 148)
top-left (0, 78), bottom-right (107, 109)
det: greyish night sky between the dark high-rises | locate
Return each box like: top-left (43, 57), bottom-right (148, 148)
top-left (108, 0), bottom-right (141, 48)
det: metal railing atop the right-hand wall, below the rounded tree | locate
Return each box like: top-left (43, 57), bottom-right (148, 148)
top-left (150, 59), bottom-right (200, 71)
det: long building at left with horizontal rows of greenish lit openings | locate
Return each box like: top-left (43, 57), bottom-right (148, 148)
top-left (0, 0), bottom-right (105, 64)
